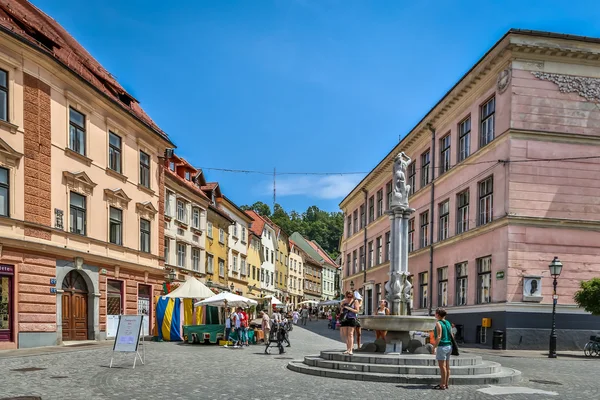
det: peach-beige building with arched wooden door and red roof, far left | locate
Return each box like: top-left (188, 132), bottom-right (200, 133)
top-left (0, 1), bottom-right (174, 349)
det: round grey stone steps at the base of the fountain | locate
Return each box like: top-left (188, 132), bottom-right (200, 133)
top-left (288, 351), bottom-right (521, 385)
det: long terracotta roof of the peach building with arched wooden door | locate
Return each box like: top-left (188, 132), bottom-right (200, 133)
top-left (0, 0), bottom-right (169, 144)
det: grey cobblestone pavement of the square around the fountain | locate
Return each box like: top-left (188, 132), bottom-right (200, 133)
top-left (0, 321), bottom-right (600, 400)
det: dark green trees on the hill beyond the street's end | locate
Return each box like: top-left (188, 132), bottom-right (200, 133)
top-left (241, 201), bottom-right (344, 260)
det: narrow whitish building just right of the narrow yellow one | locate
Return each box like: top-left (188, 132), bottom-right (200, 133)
top-left (217, 196), bottom-right (252, 296)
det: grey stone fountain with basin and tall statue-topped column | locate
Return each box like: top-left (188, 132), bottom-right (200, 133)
top-left (360, 152), bottom-right (436, 352)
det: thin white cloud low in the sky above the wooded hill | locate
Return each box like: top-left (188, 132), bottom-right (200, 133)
top-left (268, 175), bottom-right (363, 199)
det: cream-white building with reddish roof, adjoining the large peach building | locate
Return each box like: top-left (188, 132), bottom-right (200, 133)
top-left (164, 155), bottom-right (210, 280)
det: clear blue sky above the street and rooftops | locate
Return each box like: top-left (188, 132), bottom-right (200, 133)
top-left (33, 0), bottom-right (600, 211)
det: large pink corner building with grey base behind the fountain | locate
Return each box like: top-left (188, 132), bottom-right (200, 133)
top-left (340, 30), bottom-right (600, 350)
